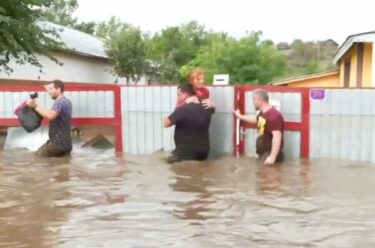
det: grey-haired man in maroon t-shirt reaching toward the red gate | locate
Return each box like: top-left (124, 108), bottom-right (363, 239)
top-left (234, 89), bottom-right (284, 164)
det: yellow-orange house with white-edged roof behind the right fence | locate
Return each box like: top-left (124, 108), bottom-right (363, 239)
top-left (271, 31), bottom-right (375, 88)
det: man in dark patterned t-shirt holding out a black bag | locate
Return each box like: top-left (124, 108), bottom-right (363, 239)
top-left (27, 80), bottom-right (72, 157)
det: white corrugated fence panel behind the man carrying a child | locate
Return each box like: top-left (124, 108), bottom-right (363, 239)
top-left (122, 86), bottom-right (234, 154)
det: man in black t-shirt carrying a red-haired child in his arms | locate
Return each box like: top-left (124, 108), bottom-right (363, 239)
top-left (164, 84), bottom-right (213, 162)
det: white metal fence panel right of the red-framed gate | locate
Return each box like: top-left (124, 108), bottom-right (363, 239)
top-left (310, 89), bottom-right (375, 162)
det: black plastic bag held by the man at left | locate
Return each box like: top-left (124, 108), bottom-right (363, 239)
top-left (14, 92), bottom-right (43, 133)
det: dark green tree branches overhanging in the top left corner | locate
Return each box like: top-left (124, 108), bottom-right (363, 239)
top-left (0, 0), bottom-right (61, 72)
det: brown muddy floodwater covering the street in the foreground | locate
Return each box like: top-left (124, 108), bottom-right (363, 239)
top-left (0, 150), bottom-right (375, 248)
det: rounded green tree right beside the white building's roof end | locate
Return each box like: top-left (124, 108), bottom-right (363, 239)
top-left (106, 26), bottom-right (148, 83)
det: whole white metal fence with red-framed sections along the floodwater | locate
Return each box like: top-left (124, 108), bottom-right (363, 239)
top-left (0, 85), bottom-right (375, 162)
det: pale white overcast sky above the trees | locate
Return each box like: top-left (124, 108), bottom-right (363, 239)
top-left (75, 0), bottom-right (375, 43)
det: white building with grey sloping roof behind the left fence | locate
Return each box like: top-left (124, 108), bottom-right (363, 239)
top-left (0, 22), bottom-right (148, 85)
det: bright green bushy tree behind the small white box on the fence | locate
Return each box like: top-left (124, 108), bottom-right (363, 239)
top-left (187, 33), bottom-right (284, 84)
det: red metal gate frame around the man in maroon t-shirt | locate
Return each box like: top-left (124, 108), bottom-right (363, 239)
top-left (233, 85), bottom-right (310, 159)
